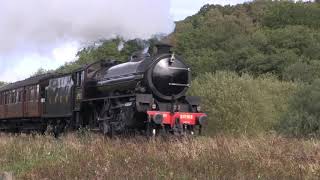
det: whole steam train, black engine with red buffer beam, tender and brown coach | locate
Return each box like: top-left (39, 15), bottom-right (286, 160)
top-left (0, 44), bottom-right (206, 136)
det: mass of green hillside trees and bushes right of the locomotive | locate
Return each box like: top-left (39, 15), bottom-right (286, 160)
top-left (170, 1), bottom-right (320, 137)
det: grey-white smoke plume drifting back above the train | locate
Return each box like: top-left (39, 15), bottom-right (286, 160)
top-left (0, 0), bottom-right (173, 55)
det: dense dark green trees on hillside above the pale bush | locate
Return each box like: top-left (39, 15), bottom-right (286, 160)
top-left (171, 1), bottom-right (320, 82)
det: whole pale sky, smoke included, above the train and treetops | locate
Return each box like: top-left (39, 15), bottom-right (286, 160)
top-left (0, 0), bottom-right (247, 82)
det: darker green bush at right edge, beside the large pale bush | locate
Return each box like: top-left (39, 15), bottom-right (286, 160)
top-left (278, 79), bottom-right (320, 137)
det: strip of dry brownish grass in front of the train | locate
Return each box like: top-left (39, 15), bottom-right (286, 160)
top-left (0, 134), bottom-right (320, 179)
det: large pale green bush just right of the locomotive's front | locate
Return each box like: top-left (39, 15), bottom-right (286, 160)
top-left (190, 72), bottom-right (298, 135)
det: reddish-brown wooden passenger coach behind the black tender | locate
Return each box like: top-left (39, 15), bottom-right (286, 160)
top-left (0, 74), bottom-right (52, 128)
